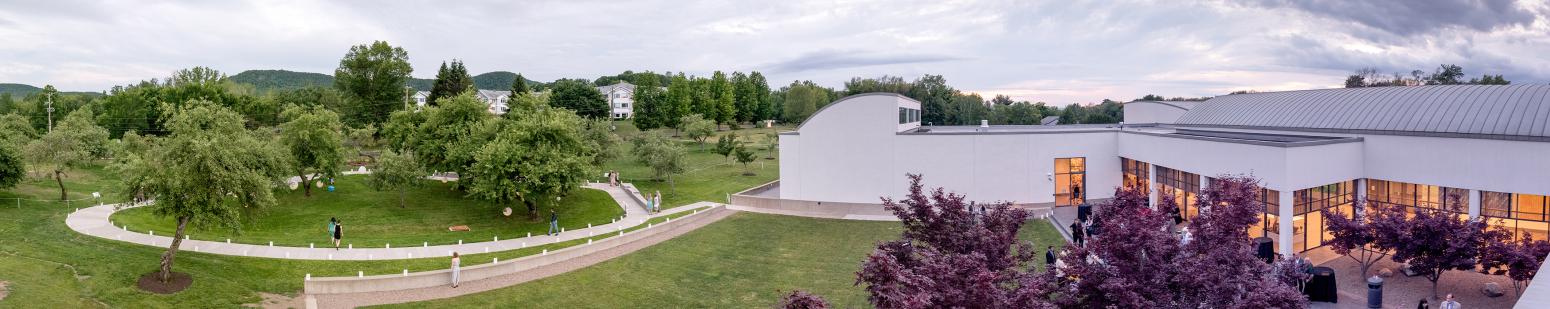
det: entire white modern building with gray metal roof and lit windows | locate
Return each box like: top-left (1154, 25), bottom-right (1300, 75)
top-left (775, 85), bottom-right (1550, 255)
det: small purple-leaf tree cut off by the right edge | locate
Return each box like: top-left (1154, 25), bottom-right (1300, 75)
top-left (1480, 227), bottom-right (1550, 293)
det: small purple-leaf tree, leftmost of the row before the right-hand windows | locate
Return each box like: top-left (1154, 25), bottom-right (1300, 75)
top-left (1322, 200), bottom-right (1404, 278)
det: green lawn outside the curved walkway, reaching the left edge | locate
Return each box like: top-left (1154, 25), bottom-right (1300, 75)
top-left (0, 168), bottom-right (687, 307)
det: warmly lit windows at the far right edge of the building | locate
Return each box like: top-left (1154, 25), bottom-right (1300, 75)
top-left (1480, 191), bottom-right (1550, 239)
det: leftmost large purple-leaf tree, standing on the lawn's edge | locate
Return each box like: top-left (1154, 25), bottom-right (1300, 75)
top-left (856, 174), bottom-right (1048, 307)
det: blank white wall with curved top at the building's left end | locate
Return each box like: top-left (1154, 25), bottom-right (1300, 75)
top-left (781, 95), bottom-right (1121, 203)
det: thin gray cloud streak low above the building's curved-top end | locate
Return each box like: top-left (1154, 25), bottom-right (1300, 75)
top-left (766, 50), bottom-right (963, 73)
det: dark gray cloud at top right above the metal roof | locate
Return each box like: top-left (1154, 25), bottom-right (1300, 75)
top-left (1256, 0), bottom-right (1538, 37)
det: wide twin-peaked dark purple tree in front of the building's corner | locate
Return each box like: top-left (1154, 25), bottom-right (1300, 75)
top-left (1035, 175), bottom-right (1307, 307)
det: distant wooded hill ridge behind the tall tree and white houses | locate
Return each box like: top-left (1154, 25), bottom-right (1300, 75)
top-left (231, 70), bottom-right (544, 92)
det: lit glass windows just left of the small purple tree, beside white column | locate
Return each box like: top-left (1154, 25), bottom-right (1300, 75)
top-left (1291, 180), bottom-right (1356, 252)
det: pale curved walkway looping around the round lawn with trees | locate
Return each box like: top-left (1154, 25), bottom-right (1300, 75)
top-left (65, 183), bottom-right (694, 261)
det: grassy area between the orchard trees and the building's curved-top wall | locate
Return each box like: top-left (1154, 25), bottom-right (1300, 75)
top-left (603, 123), bottom-right (795, 208)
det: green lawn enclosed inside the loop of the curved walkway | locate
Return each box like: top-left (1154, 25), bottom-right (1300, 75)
top-left (112, 175), bottom-right (625, 247)
